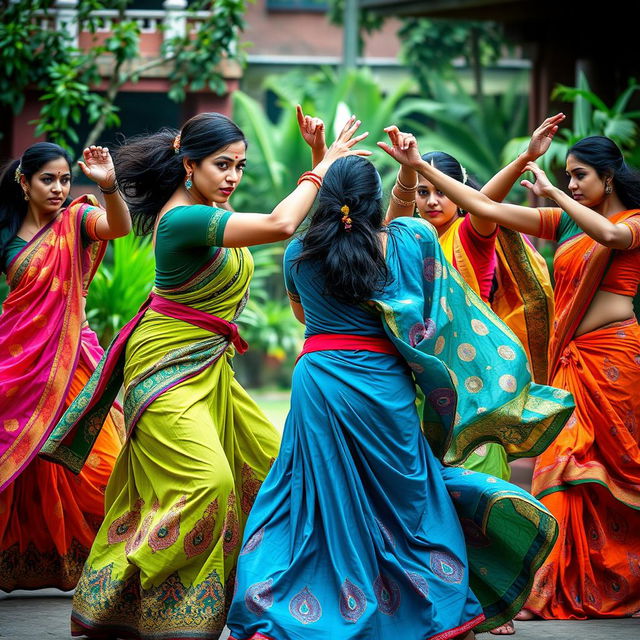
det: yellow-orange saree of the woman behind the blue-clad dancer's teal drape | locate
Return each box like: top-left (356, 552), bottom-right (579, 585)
top-left (440, 218), bottom-right (553, 480)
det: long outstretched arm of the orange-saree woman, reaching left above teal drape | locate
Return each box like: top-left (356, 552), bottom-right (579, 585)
top-left (378, 129), bottom-right (540, 235)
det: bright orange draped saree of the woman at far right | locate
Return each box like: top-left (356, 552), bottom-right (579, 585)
top-left (526, 212), bottom-right (640, 619)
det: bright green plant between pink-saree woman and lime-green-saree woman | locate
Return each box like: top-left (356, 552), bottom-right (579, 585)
top-left (87, 233), bottom-right (155, 347)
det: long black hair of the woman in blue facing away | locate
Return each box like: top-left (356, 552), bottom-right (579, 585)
top-left (296, 156), bottom-right (388, 304)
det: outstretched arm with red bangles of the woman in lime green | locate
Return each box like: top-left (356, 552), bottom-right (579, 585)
top-left (222, 116), bottom-right (371, 247)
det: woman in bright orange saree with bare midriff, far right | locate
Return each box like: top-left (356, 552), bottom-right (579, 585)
top-left (384, 136), bottom-right (640, 619)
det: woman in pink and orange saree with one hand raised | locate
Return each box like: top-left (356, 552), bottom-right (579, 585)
top-left (0, 143), bottom-right (130, 591)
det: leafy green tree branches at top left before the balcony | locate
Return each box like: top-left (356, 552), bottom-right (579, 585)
top-left (0, 0), bottom-right (246, 148)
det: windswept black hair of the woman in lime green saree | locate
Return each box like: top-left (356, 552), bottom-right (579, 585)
top-left (115, 113), bottom-right (247, 235)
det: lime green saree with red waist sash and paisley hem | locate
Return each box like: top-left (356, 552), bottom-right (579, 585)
top-left (45, 210), bottom-right (279, 640)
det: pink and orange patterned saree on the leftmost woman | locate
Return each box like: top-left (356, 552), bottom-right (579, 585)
top-left (0, 196), bottom-right (122, 591)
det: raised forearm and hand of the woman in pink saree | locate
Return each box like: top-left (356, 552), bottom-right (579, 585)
top-left (78, 146), bottom-right (131, 240)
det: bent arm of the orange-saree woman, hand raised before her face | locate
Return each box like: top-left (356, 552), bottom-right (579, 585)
top-left (521, 162), bottom-right (633, 249)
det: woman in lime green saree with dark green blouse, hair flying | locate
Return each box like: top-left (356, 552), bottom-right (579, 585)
top-left (45, 113), bottom-right (369, 639)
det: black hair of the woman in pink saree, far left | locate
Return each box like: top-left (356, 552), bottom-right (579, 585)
top-left (0, 142), bottom-right (71, 254)
